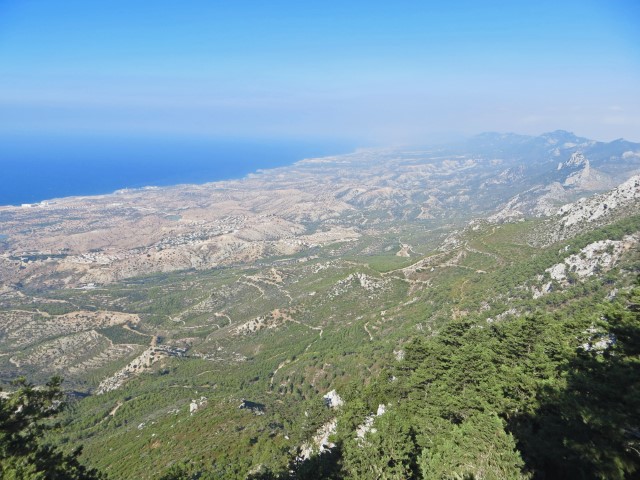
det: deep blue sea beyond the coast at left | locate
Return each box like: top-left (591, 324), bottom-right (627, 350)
top-left (0, 136), bottom-right (356, 205)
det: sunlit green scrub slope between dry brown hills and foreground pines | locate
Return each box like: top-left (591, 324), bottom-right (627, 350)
top-left (43, 208), bottom-right (640, 478)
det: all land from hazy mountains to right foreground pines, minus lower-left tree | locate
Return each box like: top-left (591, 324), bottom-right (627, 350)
top-left (0, 131), bottom-right (640, 479)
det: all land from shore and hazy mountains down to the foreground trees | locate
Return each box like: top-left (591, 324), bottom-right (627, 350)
top-left (0, 131), bottom-right (640, 478)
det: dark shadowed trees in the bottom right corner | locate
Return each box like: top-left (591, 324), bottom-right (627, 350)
top-left (509, 298), bottom-right (640, 480)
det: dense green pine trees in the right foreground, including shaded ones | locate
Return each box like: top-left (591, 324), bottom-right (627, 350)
top-left (330, 288), bottom-right (640, 479)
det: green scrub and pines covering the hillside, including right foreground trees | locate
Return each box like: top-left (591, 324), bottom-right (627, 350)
top-left (0, 209), bottom-right (640, 480)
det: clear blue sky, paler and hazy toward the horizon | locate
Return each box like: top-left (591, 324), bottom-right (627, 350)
top-left (0, 0), bottom-right (640, 144)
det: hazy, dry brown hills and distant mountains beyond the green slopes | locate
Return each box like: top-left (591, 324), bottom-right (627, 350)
top-left (0, 131), bottom-right (640, 289)
